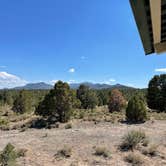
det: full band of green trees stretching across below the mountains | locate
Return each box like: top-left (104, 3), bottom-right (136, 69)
top-left (0, 75), bottom-right (166, 122)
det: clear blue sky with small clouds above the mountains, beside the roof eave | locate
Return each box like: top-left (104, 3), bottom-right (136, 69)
top-left (0, 0), bottom-right (166, 88)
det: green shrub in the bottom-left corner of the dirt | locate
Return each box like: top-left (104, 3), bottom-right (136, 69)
top-left (0, 143), bottom-right (18, 166)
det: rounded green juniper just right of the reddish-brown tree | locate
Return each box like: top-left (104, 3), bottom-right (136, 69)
top-left (126, 96), bottom-right (147, 122)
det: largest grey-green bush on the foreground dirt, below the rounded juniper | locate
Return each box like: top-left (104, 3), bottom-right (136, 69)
top-left (120, 130), bottom-right (148, 151)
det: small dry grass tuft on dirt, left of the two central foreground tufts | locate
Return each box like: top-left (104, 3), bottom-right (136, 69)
top-left (55, 146), bottom-right (72, 158)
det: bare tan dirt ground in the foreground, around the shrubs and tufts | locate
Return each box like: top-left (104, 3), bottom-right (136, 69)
top-left (0, 120), bottom-right (166, 166)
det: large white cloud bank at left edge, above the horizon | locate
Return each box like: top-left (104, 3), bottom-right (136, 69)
top-left (0, 71), bottom-right (28, 89)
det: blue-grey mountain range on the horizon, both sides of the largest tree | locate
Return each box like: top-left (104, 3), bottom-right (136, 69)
top-left (14, 82), bottom-right (134, 90)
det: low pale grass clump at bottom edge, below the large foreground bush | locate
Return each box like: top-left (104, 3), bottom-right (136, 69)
top-left (124, 153), bottom-right (143, 166)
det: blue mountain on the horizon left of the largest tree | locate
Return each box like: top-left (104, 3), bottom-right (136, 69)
top-left (14, 82), bottom-right (53, 90)
